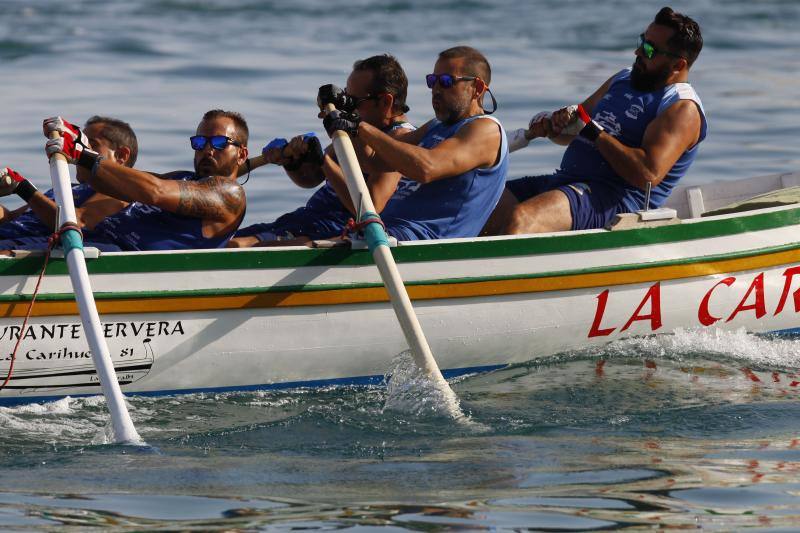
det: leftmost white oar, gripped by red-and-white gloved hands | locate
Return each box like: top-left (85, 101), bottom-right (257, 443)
top-left (50, 132), bottom-right (143, 444)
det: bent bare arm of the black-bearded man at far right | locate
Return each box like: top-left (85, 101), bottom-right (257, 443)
top-left (595, 100), bottom-right (701, 189)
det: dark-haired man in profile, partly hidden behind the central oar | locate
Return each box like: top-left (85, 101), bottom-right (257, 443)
top-left (228, 54), bottom-right (414, 247)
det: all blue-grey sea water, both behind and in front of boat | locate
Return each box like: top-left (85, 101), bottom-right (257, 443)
top-left (0, 0), bottom-right (800, 530)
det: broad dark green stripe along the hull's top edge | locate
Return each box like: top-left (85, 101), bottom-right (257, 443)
top-left (0, 208), bottom-right (800, 276)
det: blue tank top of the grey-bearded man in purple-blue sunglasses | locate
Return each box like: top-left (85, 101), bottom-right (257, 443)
top-left (381, 115), bottom-right (508, 240)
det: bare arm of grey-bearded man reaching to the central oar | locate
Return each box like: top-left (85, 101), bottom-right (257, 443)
top-left (358, 119), bottom-right (501, 183)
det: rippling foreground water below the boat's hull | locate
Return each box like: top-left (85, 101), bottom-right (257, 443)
top-left (0, 332), bottom-right (800, 531)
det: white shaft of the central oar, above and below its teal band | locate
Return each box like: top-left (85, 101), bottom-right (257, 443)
top-left (328, 111), bottom-right (450, 390)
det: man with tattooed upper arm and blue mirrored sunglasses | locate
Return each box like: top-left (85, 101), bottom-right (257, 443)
top-left (45, 109), bottom-right (248, 251)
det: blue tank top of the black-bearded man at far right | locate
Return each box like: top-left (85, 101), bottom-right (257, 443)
top-left (556, 68), bottom-right (707, 211)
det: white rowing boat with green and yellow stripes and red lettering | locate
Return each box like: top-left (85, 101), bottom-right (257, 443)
top-left (0, 173), bottom-right (800, 404)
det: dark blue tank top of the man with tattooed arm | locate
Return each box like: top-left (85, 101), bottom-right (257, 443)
top-left (85, 172), bottom-right (241, 251)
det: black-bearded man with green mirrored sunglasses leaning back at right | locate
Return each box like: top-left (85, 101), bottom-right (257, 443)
top-left (484, 7), bottom-right (706, 234)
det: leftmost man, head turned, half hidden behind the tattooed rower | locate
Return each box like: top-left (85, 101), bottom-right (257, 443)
top-left (0, 115), bottom-right (138, 250)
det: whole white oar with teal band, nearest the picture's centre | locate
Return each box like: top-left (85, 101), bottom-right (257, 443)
top-left (325, 104), bottom-right (464, 418)
